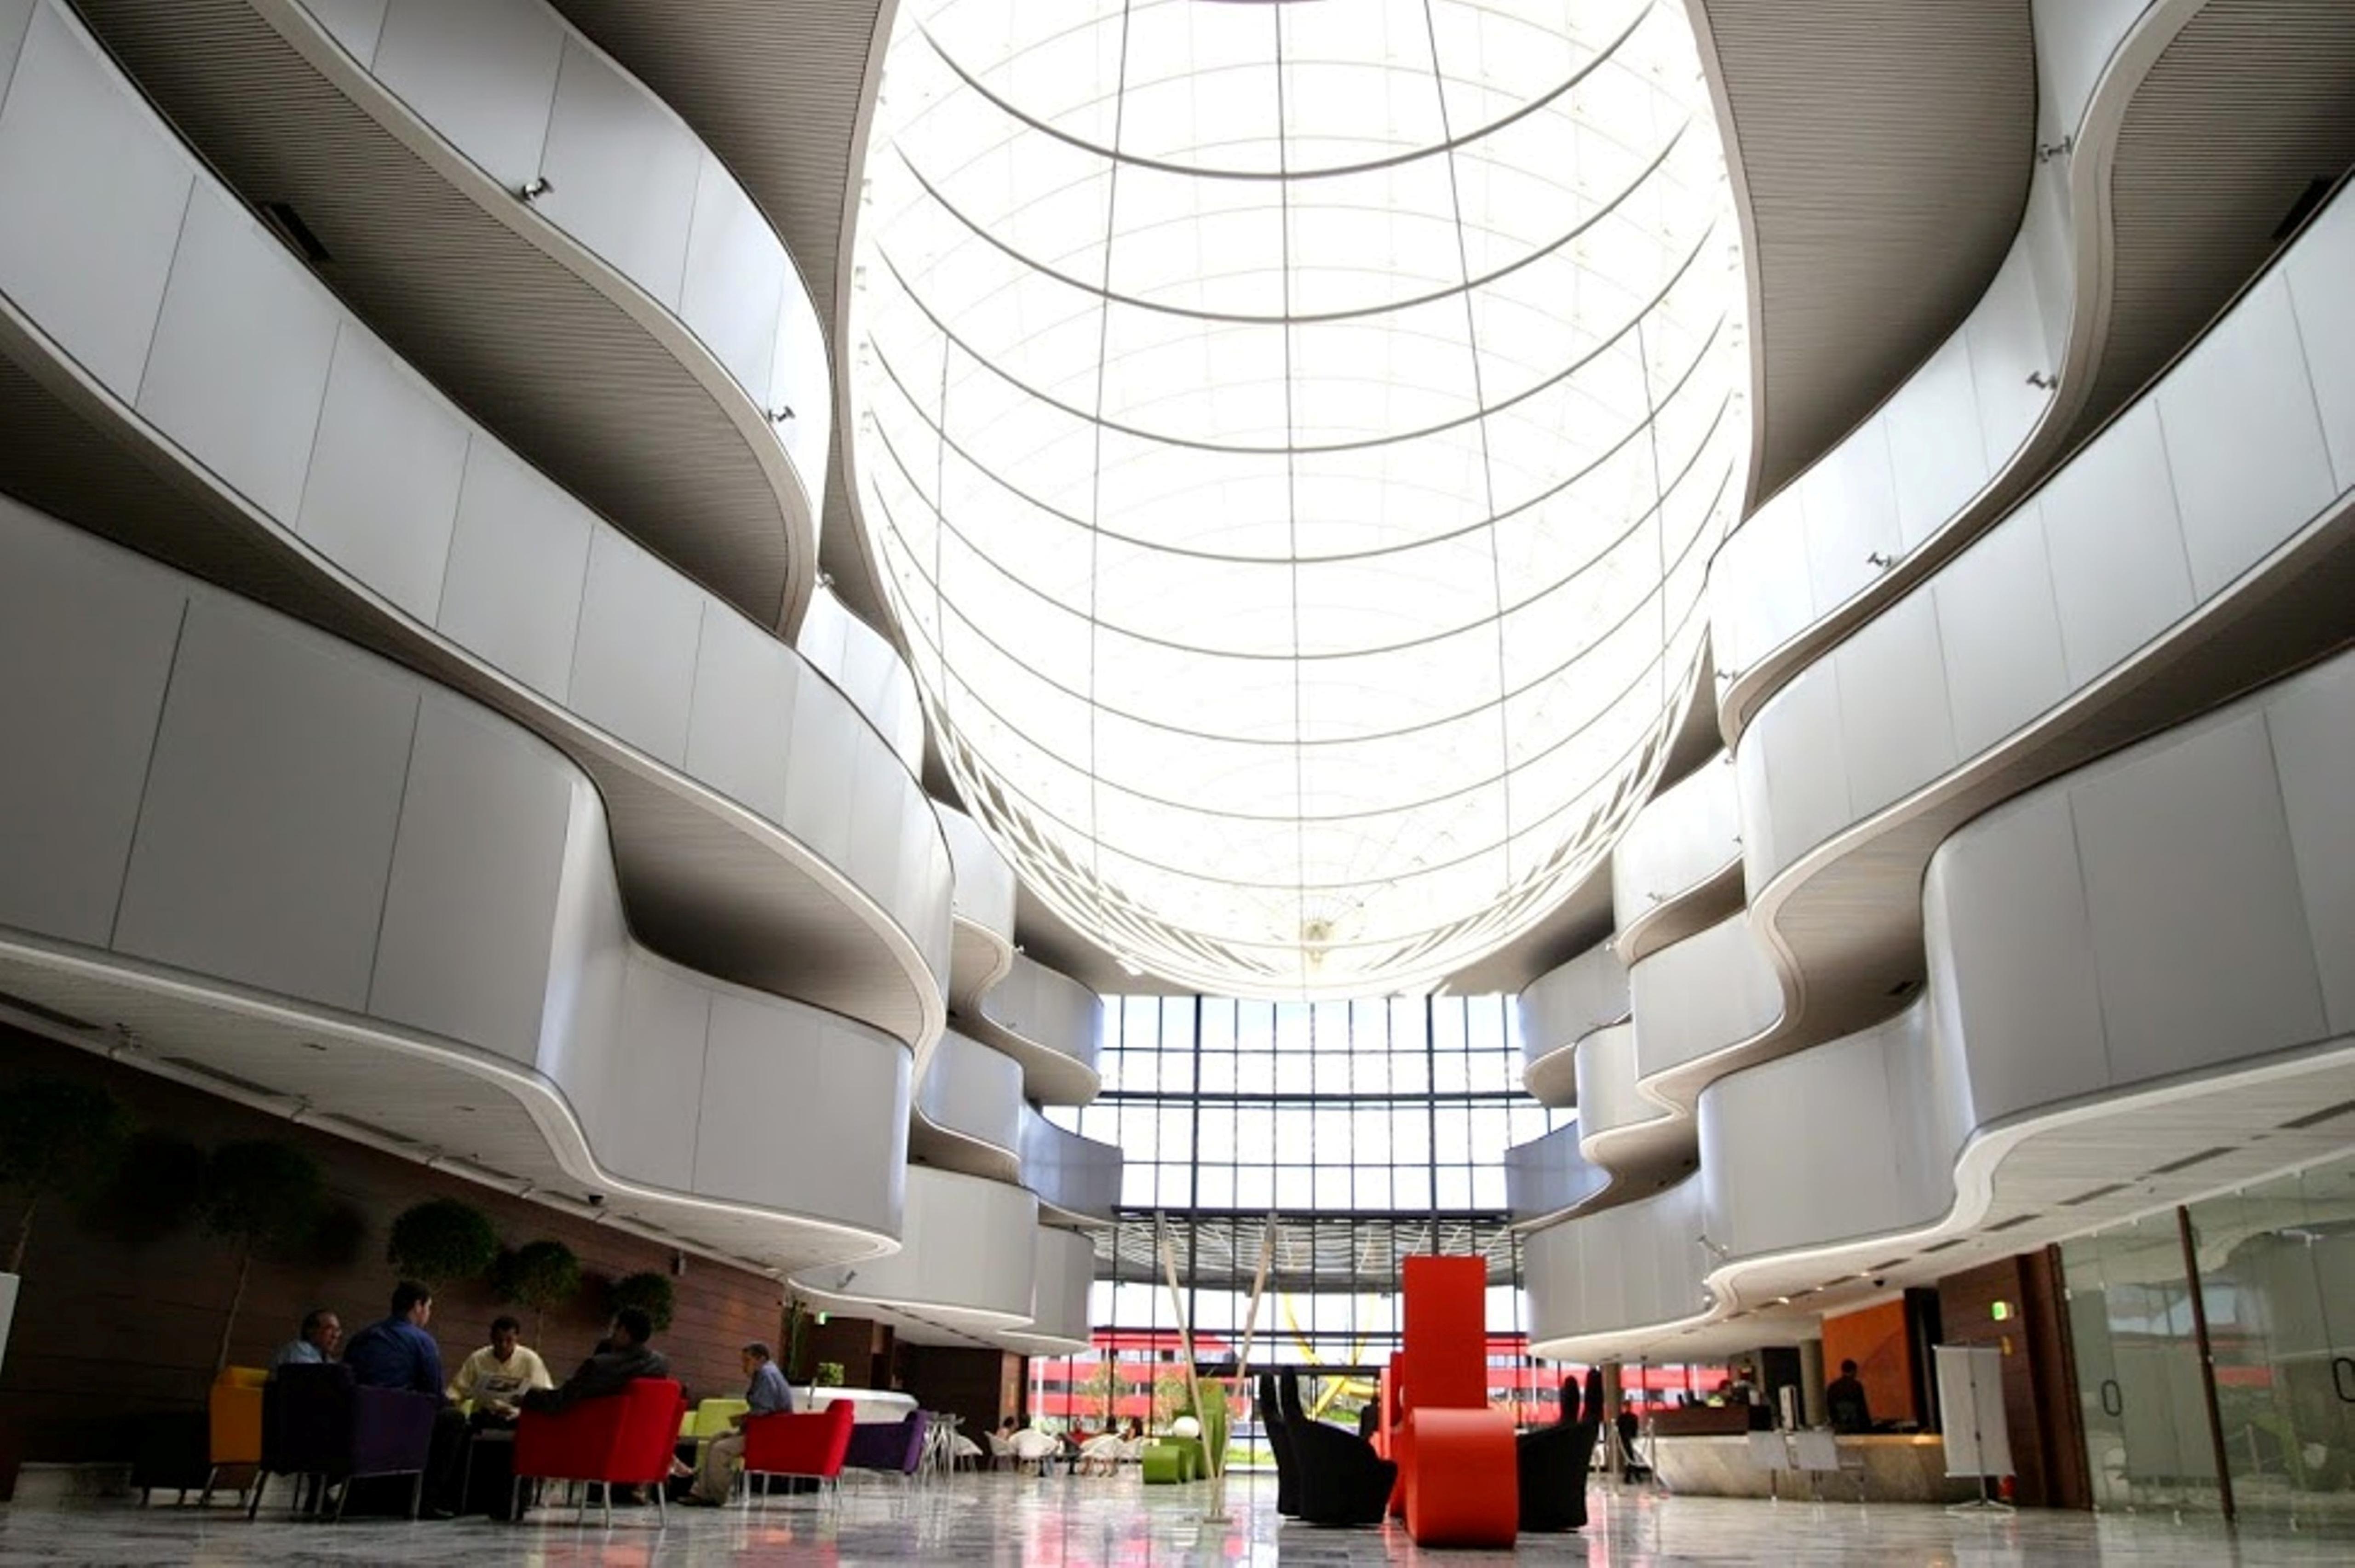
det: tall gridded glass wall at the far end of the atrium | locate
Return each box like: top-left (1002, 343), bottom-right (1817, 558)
top-left (1032, 996), bottom-right (1571, 1431)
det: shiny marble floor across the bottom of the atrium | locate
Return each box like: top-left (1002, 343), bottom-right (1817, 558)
top-left (0, 1474), bottom-right (2355, 1568)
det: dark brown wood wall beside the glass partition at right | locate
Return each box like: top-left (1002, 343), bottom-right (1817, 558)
top-left (1938, 1253), bottom-right (2094, 1509)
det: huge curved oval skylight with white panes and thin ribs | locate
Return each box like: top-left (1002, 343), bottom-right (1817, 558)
top-left (850, 0), bottom-right (1750, 996)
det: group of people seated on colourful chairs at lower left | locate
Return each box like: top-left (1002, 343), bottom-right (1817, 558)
top-left (271, 1281), bottom-right (793, 1518)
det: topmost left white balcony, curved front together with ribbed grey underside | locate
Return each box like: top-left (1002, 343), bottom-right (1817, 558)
top-left (82, 0), bottom-right (831, 629)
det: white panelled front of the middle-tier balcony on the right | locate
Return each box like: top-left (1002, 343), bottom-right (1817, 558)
top-left (1735, 181), bottom-right (2355, 902)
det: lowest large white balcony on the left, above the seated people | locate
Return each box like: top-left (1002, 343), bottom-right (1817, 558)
top-left (0, 501), bottom-right (909, 1267)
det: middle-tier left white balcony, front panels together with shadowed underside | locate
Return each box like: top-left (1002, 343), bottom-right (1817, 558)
top-left (0, 2), bottom-right (951, 1050)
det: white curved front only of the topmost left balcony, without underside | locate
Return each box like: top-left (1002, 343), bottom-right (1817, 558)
top-left (287, 0), bottom-right (833, 485)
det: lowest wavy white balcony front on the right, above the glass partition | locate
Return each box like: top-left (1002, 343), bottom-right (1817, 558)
top-left (1526, 654), bottom-right (2355, 1339)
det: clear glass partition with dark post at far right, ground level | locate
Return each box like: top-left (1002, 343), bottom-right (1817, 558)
top-left (2061, 1156), bottom-right (2355, 1523)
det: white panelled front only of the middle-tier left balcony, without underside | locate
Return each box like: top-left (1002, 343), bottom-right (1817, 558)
top-left (0, 5), bottom-right (951, 1012)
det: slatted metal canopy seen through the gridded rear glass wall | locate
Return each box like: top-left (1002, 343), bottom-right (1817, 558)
top-left (1095, 1213), bottom-right (1514, 1293)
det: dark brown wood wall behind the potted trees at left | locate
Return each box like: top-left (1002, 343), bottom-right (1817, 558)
top-left (0, 1024), bottom-right (784, 1495)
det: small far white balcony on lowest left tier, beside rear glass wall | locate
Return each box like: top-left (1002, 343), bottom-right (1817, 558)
top-left (793, 1165), bottom-right (1039, 1335)
